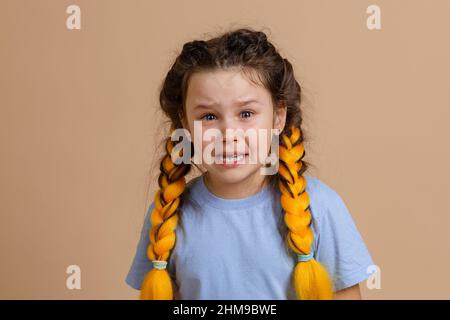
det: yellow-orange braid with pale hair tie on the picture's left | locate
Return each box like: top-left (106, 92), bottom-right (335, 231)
top-left (140, 126), bottom-right (190, 300)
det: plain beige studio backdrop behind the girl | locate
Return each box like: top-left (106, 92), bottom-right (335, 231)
top-left (0, 0), bottom-right (450, 299)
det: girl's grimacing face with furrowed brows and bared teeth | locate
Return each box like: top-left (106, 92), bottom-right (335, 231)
top-left (183, 69), bottom-right (286, 184)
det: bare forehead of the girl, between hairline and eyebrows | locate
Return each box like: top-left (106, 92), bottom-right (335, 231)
top-left (186, 69), bottom-right (271, 108)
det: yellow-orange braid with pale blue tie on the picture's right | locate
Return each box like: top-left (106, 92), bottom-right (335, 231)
top-left (278, 127), bottom-right (333, 300)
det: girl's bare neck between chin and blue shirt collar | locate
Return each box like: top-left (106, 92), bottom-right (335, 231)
top-left (203, 170), bottom-right (268, 199)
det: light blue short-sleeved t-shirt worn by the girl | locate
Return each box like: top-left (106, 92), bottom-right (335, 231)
top-left (126, 175), bottom-right (374, 300)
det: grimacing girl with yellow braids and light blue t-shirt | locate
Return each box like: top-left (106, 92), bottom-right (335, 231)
top-left (126, 29), bottom-right (373, 299)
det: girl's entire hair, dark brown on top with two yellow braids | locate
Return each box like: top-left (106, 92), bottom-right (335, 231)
top-left (140, 28), bottom-right (334, 300)
